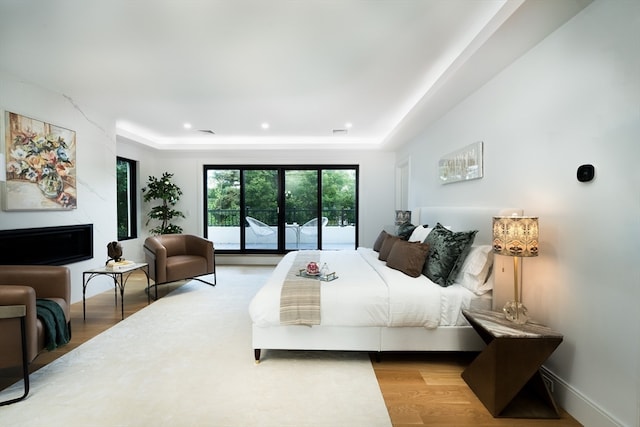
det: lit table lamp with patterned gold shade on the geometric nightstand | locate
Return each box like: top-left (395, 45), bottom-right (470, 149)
top-left (493, 215), bottom-right (538, 324)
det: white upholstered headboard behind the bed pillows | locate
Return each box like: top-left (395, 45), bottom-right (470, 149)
top-left (411, 206), bottom-right (524, 245)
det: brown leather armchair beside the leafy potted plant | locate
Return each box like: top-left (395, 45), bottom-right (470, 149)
top-left (144, 234), bottom-right (217, 297)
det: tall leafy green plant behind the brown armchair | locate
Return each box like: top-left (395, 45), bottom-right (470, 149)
top-left (142, 172), bottom-right (185, 234)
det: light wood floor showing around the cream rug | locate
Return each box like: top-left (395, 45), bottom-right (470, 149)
top-left (0, 266), bottom-right (580, 427)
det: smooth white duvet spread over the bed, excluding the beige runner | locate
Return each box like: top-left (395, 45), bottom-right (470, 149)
top-left (249, 248), bottom-right (474, 328)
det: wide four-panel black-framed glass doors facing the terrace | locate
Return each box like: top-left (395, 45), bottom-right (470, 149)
top-left (204, 165), bottom-right (358, 253)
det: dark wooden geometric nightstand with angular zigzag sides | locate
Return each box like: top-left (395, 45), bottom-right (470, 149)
top-left (462, 310), bottom-right (562, 418)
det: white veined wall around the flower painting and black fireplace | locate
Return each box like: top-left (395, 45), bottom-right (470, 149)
top-left (0, 72), bottom-right (117, 301)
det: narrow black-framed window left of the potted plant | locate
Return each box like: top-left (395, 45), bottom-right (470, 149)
top-left (116, 157), bottom-right (138, 240)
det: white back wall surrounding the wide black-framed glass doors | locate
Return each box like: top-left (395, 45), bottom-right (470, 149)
top-left (117, 137), bottom-right (395, 259)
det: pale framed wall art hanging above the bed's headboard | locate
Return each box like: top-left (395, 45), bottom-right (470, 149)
top-left (438, 142), bottom-right (484, 184)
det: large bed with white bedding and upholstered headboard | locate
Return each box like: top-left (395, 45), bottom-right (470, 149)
top-left (249, 207), bottom-right (521, 361)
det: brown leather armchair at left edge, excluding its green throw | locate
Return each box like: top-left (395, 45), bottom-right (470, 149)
top-left (0, 265), bottom-right (71, 403)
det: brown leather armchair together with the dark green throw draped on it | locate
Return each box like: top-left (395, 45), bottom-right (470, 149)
top-left (0, 265), bottom-right (71, 405)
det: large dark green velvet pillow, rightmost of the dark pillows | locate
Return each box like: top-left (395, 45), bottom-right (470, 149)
top-left (422, 223), bottom-right (478, 286)
